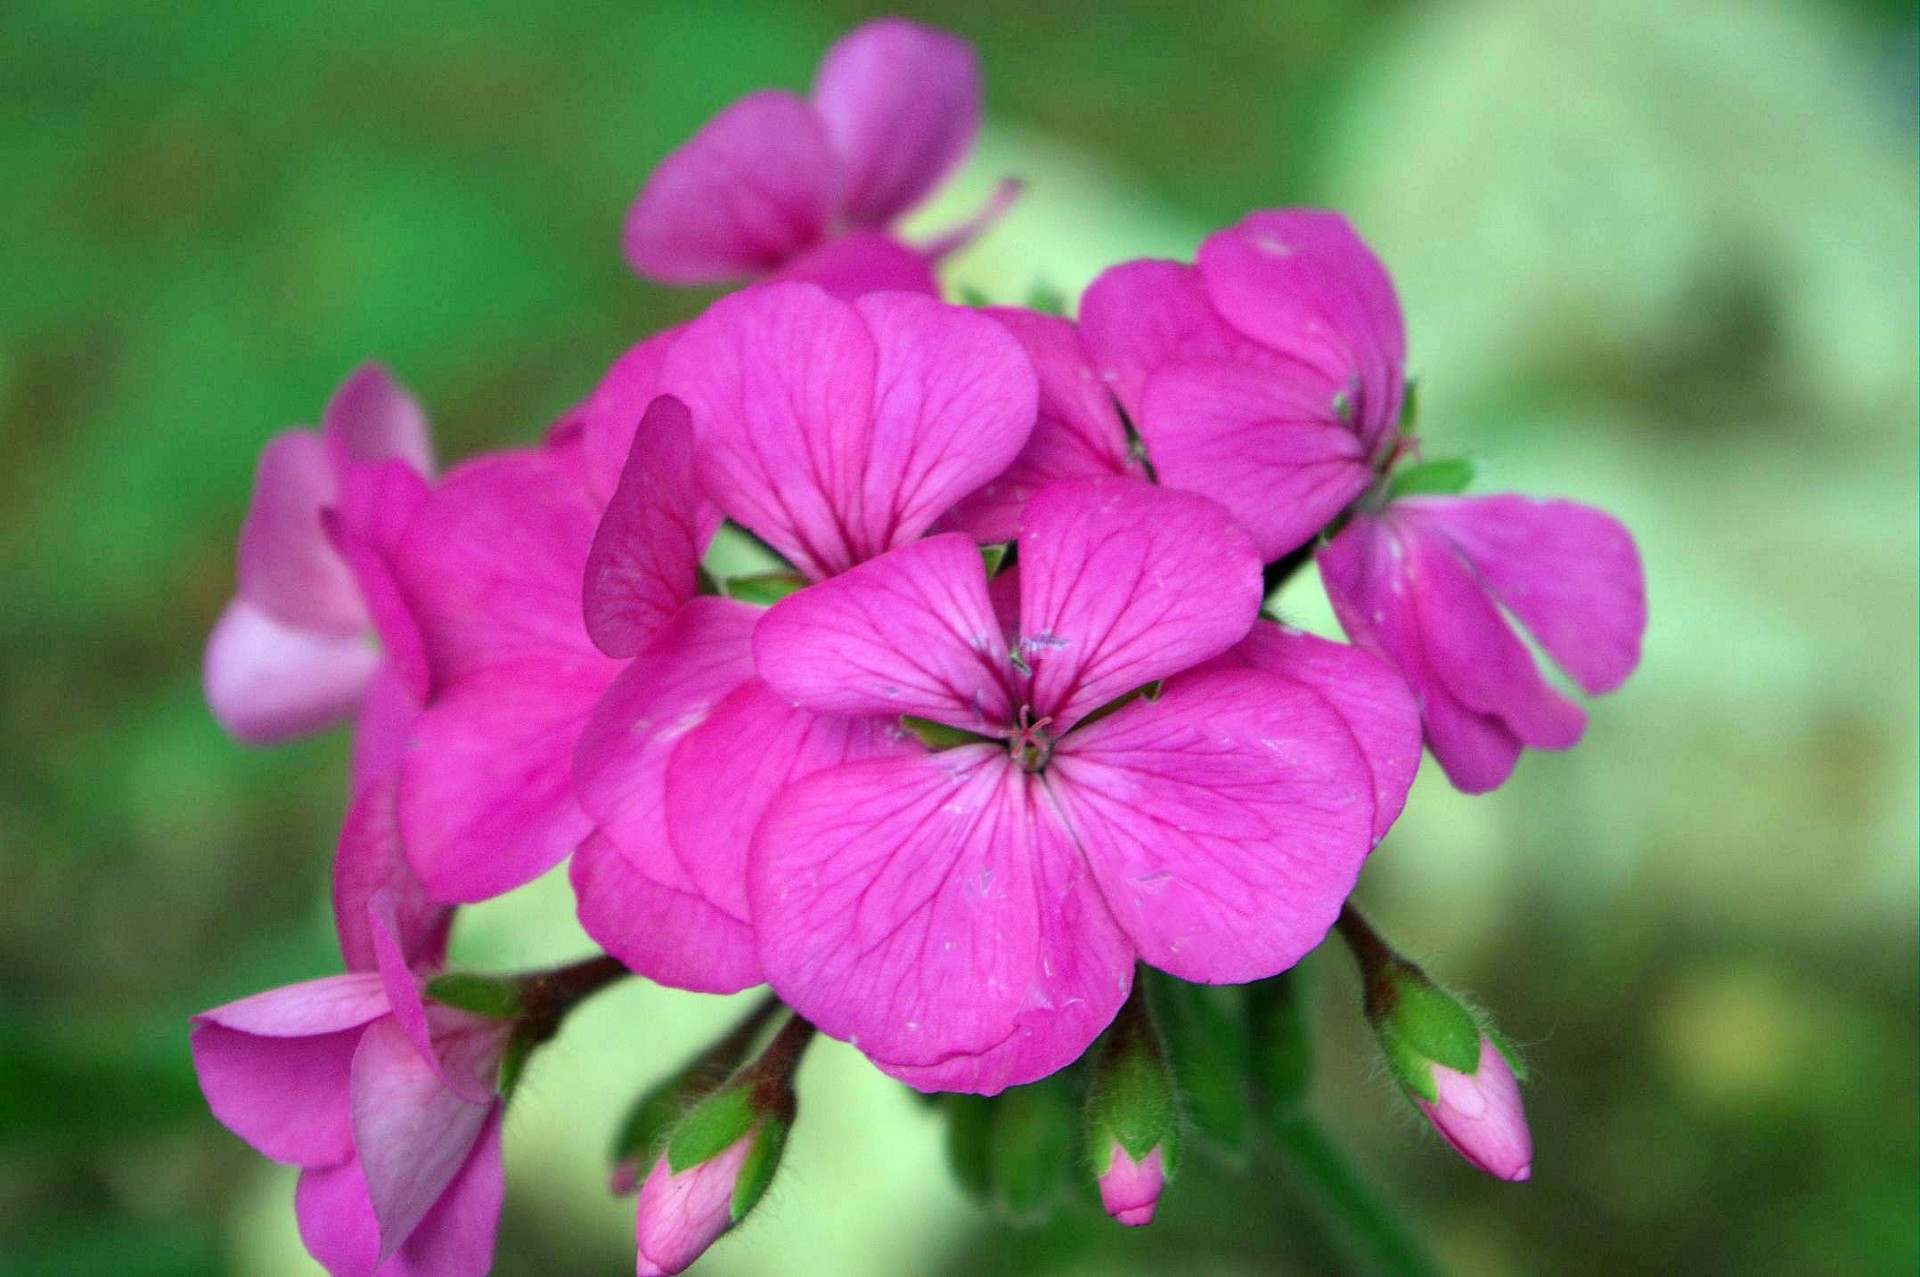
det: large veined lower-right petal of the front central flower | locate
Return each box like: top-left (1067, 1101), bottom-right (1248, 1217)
top-left (1046, 670), bottom-right (1373, 985)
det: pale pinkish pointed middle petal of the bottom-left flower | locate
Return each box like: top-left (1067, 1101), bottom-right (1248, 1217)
top-left (353, 1020), bottom-right (497, 1254)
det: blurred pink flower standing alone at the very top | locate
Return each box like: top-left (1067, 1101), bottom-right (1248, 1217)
top-left (624, 17), bottom-right (1008, 296)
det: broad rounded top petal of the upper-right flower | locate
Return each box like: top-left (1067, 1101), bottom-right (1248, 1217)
top-left (1198, 209), bottom-right (1407, 455)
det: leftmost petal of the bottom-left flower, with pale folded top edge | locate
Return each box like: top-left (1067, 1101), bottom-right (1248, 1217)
top-left (192, 976), bottom-right (386, 1166)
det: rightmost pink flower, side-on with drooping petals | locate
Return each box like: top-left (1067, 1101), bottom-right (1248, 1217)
top-left (1319, 495), bottom-right (1647, 793)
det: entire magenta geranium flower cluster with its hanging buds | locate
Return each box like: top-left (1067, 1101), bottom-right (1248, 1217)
top-left (194, 21), bottom-right (1645, 1275)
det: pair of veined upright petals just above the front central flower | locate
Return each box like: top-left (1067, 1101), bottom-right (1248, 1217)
top-left (662, 284), bottom-right (1037, 580)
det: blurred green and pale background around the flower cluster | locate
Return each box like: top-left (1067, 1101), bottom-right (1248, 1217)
top-left (0, 0), bottom-right (1920, 1277)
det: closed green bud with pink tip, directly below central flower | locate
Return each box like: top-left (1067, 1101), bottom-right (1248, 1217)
top-left (1087, 989), bottom-right (1179, 1227)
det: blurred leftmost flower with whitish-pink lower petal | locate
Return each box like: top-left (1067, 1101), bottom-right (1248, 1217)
top-left (205, 363), bottom-right (432, 745)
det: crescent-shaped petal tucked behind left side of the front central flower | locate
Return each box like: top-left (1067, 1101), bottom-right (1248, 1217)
top-left (574, 595), bottom-right (762, 895)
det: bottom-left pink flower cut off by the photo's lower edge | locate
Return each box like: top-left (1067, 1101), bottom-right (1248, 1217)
top-left (192, 897), bottom-right (511, 1277)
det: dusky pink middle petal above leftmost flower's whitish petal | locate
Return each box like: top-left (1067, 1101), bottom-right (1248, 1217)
top-left (238, 430), bottom-right (367, 634)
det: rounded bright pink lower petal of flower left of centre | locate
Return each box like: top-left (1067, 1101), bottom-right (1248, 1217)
top-left (399, 655), bottom-right (616, 904)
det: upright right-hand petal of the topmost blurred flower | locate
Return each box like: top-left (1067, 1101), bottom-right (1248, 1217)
top-left (814, 17), bottom-right (979, 227)
